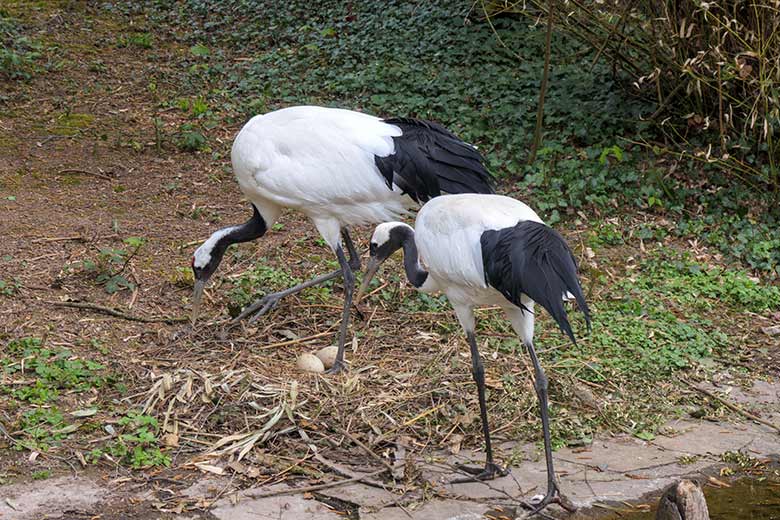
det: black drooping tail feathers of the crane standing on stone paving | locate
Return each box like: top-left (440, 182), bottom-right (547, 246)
top-left (480, 221), bottom-right (590, 344)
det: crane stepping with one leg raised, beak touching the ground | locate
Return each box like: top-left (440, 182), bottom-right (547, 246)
top-left (192, 106), bottom-right (493, 372)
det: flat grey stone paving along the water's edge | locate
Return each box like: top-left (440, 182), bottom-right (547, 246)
top-left (0, 381), bottom-right (780, 520)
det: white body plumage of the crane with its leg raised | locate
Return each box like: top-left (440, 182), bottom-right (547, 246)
top-left (231, 106), bottom-right (415, 250)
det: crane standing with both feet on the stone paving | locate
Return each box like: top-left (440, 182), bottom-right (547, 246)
top-left (356, 194), bottom-right (590, 511)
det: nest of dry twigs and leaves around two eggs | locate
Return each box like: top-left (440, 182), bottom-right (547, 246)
top-left (126, 310), bottom-right (536, 494)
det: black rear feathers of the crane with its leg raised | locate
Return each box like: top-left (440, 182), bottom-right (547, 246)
top-left (374, 118), bottom-right (493, 202)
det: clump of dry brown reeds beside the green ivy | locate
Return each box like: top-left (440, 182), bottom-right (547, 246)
top-left (483, 0), bottom-right (780, 191)
